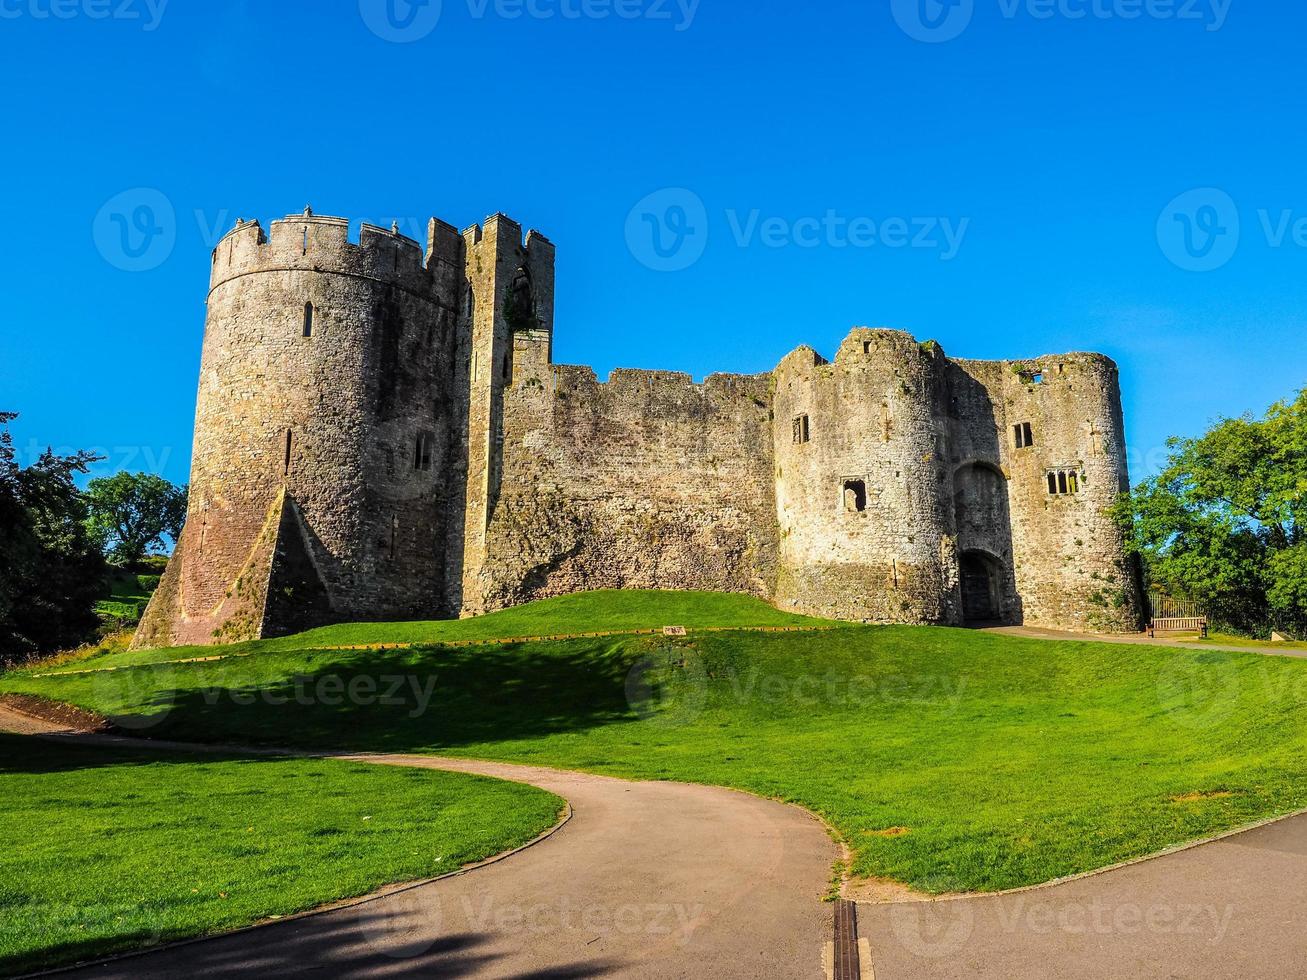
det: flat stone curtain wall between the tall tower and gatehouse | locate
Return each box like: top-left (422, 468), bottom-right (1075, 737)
top-left (467, 368), bottom-right (776, 609)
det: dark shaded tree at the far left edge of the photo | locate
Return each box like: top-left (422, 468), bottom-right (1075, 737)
top-left (0, 412), bottom-right (105, 661)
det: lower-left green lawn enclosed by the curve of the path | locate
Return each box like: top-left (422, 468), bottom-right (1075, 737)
top-left (0, 733), bottom-right (562, 975)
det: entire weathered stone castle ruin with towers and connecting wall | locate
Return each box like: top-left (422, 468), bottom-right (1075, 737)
top-left (136, 212), bottom-right (1138, 647)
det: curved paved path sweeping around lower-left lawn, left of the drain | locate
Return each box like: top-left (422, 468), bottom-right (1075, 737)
top-left (0, 710), bottom-right (838, 980)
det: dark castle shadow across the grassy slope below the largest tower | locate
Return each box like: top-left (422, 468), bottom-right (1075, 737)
top-left (131, 640), bottom-right (642, 751)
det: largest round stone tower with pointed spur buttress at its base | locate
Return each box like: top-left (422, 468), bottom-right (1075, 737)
top-left (136, 210), bottom-right (463, 645)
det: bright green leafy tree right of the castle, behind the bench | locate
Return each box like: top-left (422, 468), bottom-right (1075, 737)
top-left (1117, 388), bottom-right (1307, 635)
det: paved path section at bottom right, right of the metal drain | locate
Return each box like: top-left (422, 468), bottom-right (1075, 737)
top-left (857, 815), bottom-right (1307, 980)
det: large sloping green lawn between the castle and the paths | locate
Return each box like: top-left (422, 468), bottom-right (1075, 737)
top-left (0, 593), bottom-right (1307, 892)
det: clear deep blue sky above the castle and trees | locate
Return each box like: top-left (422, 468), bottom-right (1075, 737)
top-left (0, 0), bottom-right (1307, 482)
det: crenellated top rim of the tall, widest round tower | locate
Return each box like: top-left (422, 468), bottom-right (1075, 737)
top-left (210, 210), bottom-right (461, 295)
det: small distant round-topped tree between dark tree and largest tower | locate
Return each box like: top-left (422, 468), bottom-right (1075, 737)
top-left (86, 473), bottom-right (187, 566)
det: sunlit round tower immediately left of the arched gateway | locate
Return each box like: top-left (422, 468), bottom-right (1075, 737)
top-left (774, 328), bottom-right (958, 622)
